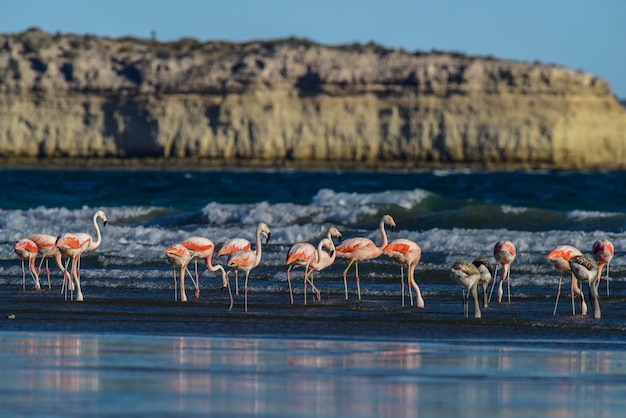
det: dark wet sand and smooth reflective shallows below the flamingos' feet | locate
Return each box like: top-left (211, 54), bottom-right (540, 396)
top-left (0, 285), bottom-right (626, 417)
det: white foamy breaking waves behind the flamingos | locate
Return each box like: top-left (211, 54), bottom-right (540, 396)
top-left (0, 185), bottom-right (626, 288)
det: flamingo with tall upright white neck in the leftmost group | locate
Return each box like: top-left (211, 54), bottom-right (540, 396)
top-left (56, 210), bottom-right (107, 302)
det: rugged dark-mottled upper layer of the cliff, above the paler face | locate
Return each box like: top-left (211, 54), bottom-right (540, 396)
top-left (0, 29), bottom-right (611, 96)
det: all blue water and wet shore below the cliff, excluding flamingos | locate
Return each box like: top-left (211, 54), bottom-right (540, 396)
top-left (0, 169), bottom-right (626, 417)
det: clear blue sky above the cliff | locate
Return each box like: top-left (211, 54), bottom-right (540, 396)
top-left (0, 0), bottom-right (626, 99)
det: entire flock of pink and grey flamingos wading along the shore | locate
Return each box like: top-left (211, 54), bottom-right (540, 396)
top-left (9, 210), bottom-right (615, 319)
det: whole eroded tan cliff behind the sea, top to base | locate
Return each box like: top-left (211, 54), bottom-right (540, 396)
top-left (0, 30), bottom-right (626, 168)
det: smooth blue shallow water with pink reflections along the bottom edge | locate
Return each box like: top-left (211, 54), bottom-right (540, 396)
top-left (0, 332), bottom-right (626, 417)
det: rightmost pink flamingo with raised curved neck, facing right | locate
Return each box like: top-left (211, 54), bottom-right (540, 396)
top-left (336, 215), bottom-right (396, 300)
